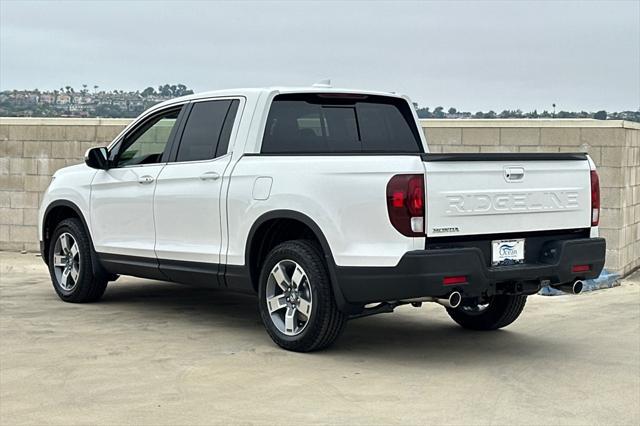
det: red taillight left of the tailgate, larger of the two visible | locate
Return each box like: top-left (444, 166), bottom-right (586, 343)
top-left (387, 175), bottom-right (425, 237)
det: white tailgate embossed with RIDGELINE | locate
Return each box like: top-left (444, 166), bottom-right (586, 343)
top-left (423, 153), bottom-right (591, 237)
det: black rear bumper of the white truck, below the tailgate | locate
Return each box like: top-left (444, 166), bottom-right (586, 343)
top-left (336, 238), bottom-right (606, 304)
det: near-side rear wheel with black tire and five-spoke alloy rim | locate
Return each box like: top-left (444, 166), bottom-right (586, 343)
top-left (258, 240), bottom-right (347, 352)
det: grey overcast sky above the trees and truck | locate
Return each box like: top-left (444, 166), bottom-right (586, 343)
top-left (0, 0), bottom-right (640, 112)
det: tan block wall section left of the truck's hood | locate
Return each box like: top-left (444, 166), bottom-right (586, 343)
top-left (0, 118), bottom-right (130, 251)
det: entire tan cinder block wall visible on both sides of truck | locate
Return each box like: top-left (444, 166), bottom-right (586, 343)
top-left (0, 118), bottom-right (640, 274)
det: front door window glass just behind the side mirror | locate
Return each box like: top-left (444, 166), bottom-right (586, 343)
top-left (116, 108), bottom-right (180, 167)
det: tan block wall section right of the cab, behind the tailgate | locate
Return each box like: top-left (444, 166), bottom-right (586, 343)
top-left (421, 119), bottom-right (640, 274)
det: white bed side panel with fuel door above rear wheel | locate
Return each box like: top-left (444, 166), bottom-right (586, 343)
top-left (222, 155), bottom-right (424, 266)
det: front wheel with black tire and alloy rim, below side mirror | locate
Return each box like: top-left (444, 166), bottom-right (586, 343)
top-left (49, 218), bottom-right (108, 303)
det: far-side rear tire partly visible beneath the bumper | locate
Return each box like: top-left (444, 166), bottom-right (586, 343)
top-left (447, 295), bottom-right (527, 330)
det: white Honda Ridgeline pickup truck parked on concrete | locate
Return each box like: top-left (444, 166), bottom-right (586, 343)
top-left (39, 87), bottom-right (605, 351)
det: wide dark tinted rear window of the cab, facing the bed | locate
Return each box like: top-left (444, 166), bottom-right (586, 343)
top-left (262, 93), bottom-right (422, 154)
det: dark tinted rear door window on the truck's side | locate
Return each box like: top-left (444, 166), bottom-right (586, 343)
top-left (176, 100), bottom-right (239, 161)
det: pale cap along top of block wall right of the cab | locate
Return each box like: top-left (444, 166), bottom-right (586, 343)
top-left (420, 118), bottom-right (640, 130)
